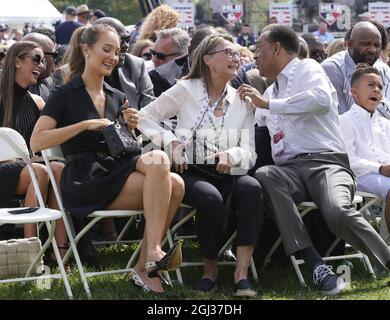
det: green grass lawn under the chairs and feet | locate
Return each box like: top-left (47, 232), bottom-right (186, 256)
top-left (0, 245), bottom-right (390, 300)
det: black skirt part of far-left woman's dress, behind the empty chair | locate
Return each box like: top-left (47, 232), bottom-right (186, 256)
top-left (0, 161), bottom-right (26, 207)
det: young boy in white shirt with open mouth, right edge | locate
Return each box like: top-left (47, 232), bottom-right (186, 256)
top-left (340, 68), bottom-right (390, 240)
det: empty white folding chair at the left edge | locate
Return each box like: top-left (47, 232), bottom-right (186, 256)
top-left (0, 128), bottom-right (73, 298)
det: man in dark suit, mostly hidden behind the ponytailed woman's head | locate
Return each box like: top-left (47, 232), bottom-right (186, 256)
top-left (94, 17), bottom-right (155, 110)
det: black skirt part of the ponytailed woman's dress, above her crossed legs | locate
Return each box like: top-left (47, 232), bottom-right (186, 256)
top-left (61, 156), bottom-right (139, 219)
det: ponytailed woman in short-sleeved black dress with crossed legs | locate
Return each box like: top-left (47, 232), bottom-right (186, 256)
top-left (31, 24), bottom-right (184, 292)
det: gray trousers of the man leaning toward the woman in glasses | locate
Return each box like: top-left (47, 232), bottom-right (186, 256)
top-left (255, 152), bottom-right (390, 271)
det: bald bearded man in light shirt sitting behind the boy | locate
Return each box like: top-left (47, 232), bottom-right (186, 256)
top-left (322, 21), bottom-right (390, 118)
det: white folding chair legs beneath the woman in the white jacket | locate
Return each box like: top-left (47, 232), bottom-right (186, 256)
top-left (158, 204), bottom-right (258, 284)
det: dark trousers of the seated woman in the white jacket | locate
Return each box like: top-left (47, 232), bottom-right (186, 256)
top-left (182, 171), bottom-right (264, 259)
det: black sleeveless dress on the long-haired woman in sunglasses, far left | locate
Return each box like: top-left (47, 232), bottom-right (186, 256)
top-left (0, 82), bottom-right (40, 207)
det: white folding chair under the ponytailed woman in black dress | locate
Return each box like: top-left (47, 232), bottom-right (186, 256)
top-left (42, 146), bottom-right (143, 298)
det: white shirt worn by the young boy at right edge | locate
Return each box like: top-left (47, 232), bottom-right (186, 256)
top-left (340, 104), bottom-right (390, 177)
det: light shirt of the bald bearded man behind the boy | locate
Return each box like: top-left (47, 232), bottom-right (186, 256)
top-left (321, 50), bottom-right (390, 119)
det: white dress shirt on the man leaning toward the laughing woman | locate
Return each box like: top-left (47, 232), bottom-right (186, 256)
top-left (256, 58), bottom-right (345, 164)
